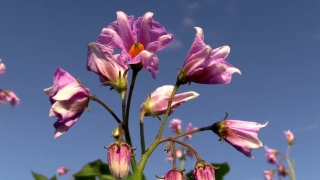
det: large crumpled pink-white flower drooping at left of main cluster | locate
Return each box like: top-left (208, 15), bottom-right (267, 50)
top-left (44, 68), bottom-right (90, 139)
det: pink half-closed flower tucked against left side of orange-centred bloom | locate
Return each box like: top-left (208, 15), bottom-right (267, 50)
top-left (87, 42), bottom-right (128, 92)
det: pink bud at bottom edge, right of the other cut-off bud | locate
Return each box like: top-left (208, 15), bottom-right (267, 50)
top-left (193, 160), bottom-right (216, 180)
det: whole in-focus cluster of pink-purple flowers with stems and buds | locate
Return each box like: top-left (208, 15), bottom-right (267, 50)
top-left (44, 11), bottom-right (268, 180)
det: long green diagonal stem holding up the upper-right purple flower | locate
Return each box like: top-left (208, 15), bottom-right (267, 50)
top-left (134, 81), bottom-right (180, 180)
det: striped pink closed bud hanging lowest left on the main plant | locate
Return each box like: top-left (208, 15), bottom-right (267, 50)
top-left (108, 140), bottom-right (131, 179)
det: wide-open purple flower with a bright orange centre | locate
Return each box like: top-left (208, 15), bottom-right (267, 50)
top-left (98, 11), bottom-right (173, 78)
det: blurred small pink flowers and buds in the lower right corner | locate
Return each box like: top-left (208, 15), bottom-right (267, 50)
top-left (264, 130), bottom-right (294, 180)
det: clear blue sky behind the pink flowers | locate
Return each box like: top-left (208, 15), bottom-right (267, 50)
top-left (0, 0), bottom-right (320, 180)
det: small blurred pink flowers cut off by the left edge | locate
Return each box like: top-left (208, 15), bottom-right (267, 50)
top-left (0, 59), bottom-right (20, 106)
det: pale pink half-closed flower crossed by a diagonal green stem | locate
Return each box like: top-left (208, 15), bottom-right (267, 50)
top-left (141, 85), bottom-right (199, 116)
